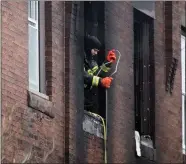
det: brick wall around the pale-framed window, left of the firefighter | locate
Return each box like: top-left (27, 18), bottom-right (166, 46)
top-left (2, 1), bottom-right (84, 163)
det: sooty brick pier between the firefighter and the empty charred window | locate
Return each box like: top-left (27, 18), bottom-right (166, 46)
top-left (105, 2), bottom-right (135, 163)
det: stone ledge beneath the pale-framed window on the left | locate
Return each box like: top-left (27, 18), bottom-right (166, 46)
top-left (28, 90), bottom-right (54, 118)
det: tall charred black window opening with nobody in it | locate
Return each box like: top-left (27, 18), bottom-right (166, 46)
top-left (133, 8), bottom-right (155, 158)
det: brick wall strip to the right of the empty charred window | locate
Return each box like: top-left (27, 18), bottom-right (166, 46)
top-left (154, 2), bottom-right (182, 163)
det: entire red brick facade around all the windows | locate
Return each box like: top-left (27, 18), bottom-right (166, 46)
top-left (1, 1), bottom-right (185, 163)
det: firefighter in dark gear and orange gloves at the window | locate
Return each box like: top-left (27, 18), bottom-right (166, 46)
top-left (84, 35), bottom-right (116, 112)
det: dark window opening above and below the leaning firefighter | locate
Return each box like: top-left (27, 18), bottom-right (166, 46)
top-left (84, 1), bottom-right (105, 118)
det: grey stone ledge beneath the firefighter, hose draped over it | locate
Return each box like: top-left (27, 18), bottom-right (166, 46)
top-left (83, 111), bottom-right (104, 139)
